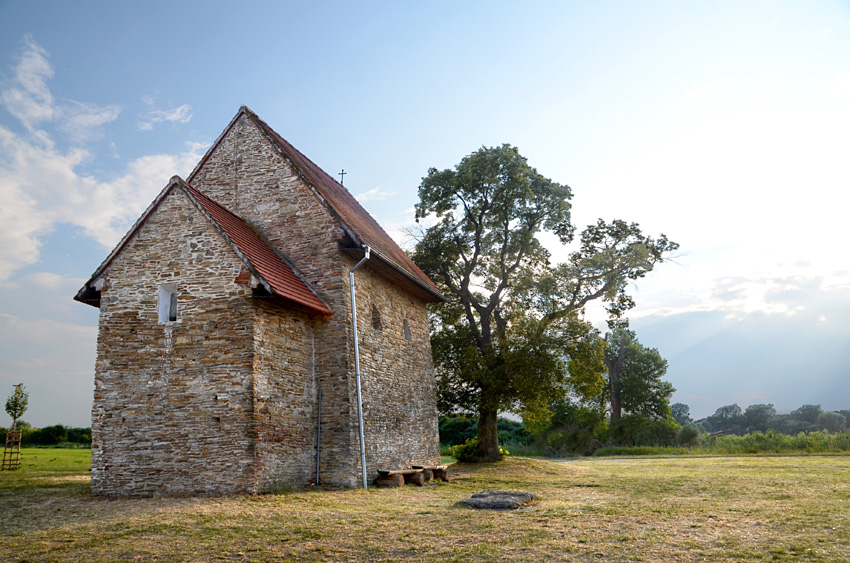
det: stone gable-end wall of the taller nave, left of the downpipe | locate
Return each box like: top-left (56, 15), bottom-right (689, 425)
top-left (189, 115), bottom-right (360, 485)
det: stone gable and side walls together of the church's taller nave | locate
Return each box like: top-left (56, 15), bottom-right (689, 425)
top-left (190, 115), bottom-right (439, 486)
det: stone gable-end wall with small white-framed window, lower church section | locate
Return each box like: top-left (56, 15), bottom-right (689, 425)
top-left (92, 190), bottom-right (255, 495)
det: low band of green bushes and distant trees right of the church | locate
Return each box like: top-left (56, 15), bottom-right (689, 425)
top-left (440, 401), bottom-right (850, 457)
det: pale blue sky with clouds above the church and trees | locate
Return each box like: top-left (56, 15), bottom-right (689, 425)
top-left (0, 0), bottom-right (850, 426)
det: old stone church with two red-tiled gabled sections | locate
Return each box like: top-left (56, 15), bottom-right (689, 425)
top-left (75, 107), bottom-right (442, 495)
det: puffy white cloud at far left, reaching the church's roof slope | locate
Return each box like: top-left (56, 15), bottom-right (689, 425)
top-left (0, 38), bottom-right (202, 280)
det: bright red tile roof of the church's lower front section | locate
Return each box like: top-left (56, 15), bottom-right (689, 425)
top-left (74, 176), bottom-right (332, 315)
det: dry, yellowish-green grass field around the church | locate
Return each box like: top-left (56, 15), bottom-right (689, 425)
top-left (0, 450), bottom-right (850, 562)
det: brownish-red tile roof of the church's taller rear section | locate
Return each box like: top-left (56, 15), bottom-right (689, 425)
top-left (189, 106), bottom-right (444, 301)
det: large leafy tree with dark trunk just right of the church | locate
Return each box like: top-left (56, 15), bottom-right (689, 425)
top-left (414, 145), bottom-right (677, 460)
